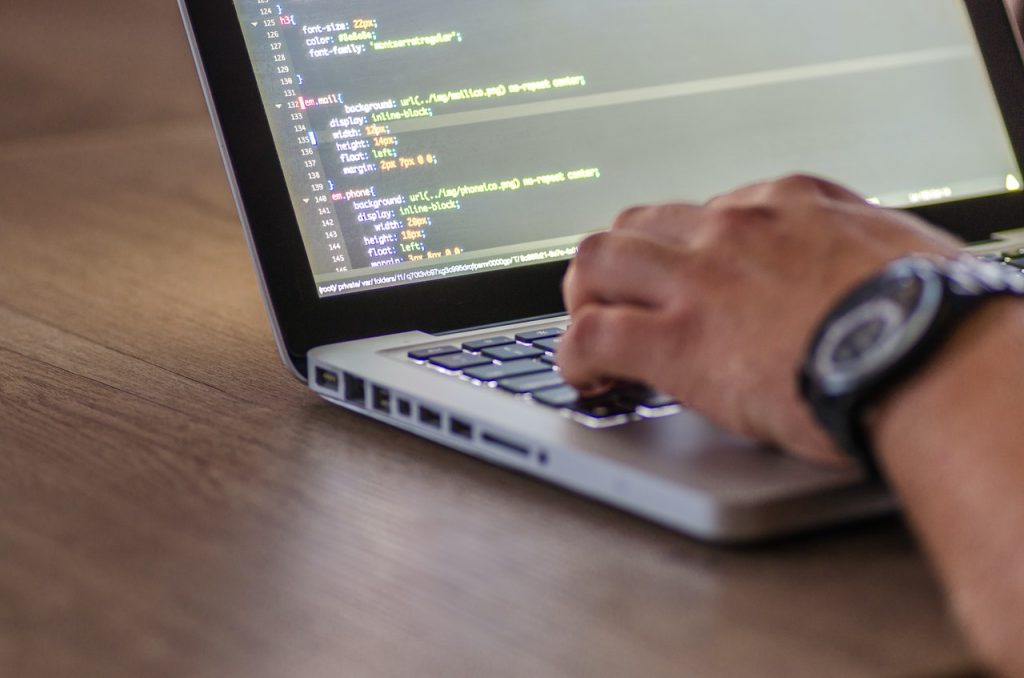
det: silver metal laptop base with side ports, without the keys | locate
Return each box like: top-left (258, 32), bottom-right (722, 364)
top-left (309, 320), bottom-right (895, 544)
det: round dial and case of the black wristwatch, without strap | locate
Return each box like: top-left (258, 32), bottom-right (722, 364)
top-left (812, 262), bottom-right (942, 395)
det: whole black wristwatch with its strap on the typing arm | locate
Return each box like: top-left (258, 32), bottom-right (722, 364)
top-left (800, 255), bottom-right (1024, 479)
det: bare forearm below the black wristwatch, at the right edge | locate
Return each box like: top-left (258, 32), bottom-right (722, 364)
top-left (873, 300), bottom-right (1024, 675)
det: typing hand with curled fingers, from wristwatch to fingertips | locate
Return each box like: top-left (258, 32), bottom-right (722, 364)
top-left (558, 176), bottom-right (958, 464)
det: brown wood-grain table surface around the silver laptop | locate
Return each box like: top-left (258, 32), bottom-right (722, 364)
top-left (0, 0), bottom-right (972, 678)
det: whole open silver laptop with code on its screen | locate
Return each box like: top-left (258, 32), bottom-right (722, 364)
top-left (180, 0), bottom-right (1024, 543)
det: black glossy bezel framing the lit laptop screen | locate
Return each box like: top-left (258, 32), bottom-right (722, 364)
top-left (179, 0), bottom-right (1024, 374)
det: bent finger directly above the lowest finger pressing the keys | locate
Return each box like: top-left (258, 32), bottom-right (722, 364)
top-left (562, 231), bottom-right (684, 313)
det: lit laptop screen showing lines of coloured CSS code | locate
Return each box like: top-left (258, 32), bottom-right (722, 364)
top-left (234, 0), bottom-right (1022, 297)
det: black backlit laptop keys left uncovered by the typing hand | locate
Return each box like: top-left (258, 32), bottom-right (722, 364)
top-left (409, 327), bottom-right (682, 428)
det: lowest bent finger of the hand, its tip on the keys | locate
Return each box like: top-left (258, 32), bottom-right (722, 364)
top-left (557, 304), bottom-right (678, 391)
